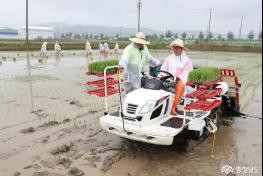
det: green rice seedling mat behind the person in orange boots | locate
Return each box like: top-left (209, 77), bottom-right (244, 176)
top-left (188, 67), bottom-right (221, 84)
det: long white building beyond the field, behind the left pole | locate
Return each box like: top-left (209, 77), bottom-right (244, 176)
top-left (18, 26), bottom-right (55, 40)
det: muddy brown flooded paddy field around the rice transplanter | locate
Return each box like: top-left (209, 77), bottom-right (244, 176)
top-left (0, 50), bottom-right (262, 176)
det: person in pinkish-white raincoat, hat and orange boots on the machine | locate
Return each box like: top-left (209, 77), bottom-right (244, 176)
top-left (161, 39), bottom-right (193, 115)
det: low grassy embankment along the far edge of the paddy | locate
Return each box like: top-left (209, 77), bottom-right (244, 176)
top-left (0, 40), bottom-right (262, 53)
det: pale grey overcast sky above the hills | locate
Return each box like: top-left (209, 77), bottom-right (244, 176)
top-left (0, 0), bottom-right (262, 34)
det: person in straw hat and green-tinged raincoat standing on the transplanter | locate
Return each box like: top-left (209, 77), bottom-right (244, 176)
top-left (119, 32), bottom-right (160, 93)
